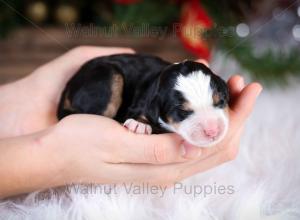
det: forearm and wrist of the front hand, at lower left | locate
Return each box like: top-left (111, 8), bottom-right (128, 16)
top-left (0, 128), bottom-right (67, 198)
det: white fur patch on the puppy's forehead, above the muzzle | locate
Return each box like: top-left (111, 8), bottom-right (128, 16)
top-left (175, 71), bottom-right (213, 109)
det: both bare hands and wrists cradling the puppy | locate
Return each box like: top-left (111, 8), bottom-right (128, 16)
top-left (0, 46), bottom-right (262, 197)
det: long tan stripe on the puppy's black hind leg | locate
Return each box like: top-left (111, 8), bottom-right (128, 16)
top-left (103, 74), bottom-right (124, 118)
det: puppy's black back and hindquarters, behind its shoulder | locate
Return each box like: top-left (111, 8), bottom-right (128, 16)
top-left (57, 54), bottom-right (169, 119)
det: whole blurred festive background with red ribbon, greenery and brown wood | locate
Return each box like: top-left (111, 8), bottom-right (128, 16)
top-left (0, 0), bottom-right (300, 85)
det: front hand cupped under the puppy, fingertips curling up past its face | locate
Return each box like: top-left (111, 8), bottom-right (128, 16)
top-left (41, 76), bottom-right (262, 185)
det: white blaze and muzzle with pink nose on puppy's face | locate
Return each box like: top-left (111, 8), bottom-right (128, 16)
top-left (160, 71), bottom-right (228, 147)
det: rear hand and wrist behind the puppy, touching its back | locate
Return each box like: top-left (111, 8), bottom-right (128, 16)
top-left (0, 46), bottom-right (133, 138)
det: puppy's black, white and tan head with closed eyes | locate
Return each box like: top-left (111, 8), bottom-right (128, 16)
top-left (150, 61), bottom-right (229, 147)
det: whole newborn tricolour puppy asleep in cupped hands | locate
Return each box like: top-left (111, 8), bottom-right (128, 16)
top-left (57, 54), bottom-right (229, 147)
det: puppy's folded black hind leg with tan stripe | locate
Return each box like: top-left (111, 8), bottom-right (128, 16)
top-left (57, 63), bottom-right (124, 119)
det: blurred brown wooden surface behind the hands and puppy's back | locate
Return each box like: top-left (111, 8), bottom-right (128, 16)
top-left (0, 28), bottom-right (193, 84)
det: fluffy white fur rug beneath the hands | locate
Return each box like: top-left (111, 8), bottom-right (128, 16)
top-left (0, 59), bottom-right (300, 220)
